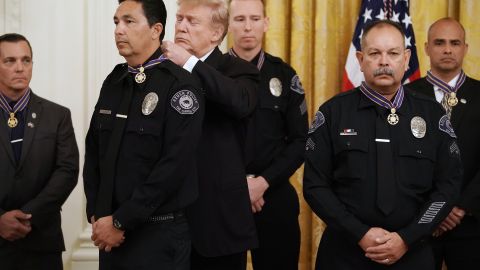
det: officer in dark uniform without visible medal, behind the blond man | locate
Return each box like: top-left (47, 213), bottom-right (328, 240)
top-left (229, 0), bottom-right (308, 270)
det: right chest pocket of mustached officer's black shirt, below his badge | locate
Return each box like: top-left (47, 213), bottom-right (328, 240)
top-left (398, 140), bottom-right (436, 192)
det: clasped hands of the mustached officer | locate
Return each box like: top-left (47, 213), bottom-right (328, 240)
top-left (358, 227), bottom-right (408, 265)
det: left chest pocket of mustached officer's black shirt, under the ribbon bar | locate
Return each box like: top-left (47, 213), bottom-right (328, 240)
top-left (333, 136), bottom-right (369, 181)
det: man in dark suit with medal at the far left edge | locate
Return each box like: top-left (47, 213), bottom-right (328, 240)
top-left (0, 34), bottom-right (78, 270)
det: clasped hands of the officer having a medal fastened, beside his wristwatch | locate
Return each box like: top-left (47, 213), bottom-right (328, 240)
top-left (90, 216), bottom-right (125, 252)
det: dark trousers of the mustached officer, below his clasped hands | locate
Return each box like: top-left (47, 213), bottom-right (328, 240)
top-left (315, 227), bottom-right (434, 270)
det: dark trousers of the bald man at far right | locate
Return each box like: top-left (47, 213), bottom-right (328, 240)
top-left (432, 217), bottom-right (480, 270)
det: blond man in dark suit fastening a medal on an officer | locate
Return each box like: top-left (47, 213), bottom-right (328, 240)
top-left (162, 0), bottom-right (258, 270)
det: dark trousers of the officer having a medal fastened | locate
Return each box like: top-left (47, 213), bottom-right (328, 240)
top-left (100, 217), bottom-right (191, 270)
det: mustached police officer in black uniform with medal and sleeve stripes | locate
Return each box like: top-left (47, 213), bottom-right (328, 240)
top-left (304, 21), bottom-right (461, 270)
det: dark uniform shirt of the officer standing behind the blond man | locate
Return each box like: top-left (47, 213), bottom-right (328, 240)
top-left (247, 50), bottom-right (308, 187)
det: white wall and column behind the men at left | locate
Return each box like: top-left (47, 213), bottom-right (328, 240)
top-left (0, 0), bottom-right (185, 270)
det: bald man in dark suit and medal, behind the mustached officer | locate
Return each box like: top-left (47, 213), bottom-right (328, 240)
top-left (408, 18), bottom-right (480, 270)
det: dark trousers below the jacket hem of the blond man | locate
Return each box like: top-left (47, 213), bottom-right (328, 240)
top-left (191, 248), bottom-right (247, 270)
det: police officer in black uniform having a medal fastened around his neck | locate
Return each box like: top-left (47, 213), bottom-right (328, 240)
top-left (83, 0), bottom-right (204, 269)
